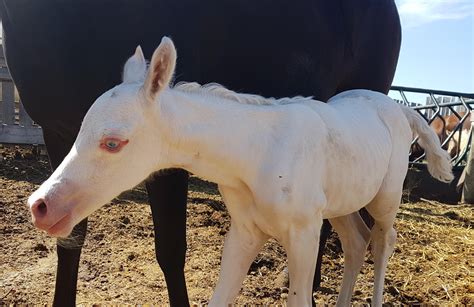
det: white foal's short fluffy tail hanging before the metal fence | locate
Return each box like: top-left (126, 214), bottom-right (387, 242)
top-left (401, 106), bottom-right (454, 182)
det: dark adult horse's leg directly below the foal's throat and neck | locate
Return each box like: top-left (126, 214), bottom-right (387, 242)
top-left (146, 169), bottom-right (189, 306)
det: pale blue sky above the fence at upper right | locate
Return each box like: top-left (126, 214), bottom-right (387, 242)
top-left (393, 0), bottom-right (474, 93)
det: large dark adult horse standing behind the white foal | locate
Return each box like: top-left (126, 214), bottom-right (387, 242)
top-left (0, 0), bottom-right (401, 306)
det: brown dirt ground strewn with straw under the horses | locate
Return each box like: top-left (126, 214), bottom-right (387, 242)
top-left (0, 145), bottom-right (474, 306)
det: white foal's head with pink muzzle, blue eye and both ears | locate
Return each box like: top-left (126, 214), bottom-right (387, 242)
top-left (28, 37), bottom-right (180, 237)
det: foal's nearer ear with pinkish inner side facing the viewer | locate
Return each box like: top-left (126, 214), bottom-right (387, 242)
top-left (144, 36), bottom-right (176, 101)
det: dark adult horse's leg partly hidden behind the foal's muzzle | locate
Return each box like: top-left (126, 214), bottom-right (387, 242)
top-left (43, 126), bottom-right (87, 307)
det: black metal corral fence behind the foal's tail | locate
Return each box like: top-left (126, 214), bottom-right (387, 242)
top-left (390, 86), bottom-right (474, 204)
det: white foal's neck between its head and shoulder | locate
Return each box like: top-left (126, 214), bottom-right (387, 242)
top-left (159, 89), bottom-right (262, 186)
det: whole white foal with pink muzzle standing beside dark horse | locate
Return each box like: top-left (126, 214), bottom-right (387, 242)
top-left (29, 38), bottom-right (452, 307)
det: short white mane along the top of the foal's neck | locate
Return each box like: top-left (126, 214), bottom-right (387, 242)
top-left (172, 82), bottom-right (313, 105)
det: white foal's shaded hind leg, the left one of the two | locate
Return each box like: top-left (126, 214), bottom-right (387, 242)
top-left (329, 212), bottom-right (370, 306)
